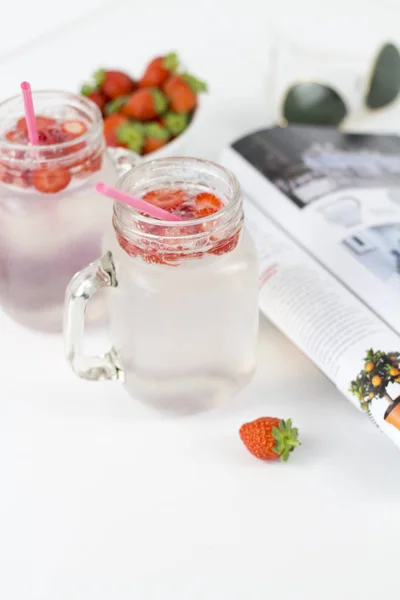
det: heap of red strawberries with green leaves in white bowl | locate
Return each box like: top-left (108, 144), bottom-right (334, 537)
top-left (81, 52), bottom-right (207, 154)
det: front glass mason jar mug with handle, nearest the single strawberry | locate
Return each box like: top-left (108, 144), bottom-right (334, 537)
top-left (64, 158), bottom-right (258, 413)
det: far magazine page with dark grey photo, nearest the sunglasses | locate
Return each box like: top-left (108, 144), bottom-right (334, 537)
top-left (225, 126), bottom-right (400, 333)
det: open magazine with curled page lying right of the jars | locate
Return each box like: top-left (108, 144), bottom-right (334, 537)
top-left (221, 126), bottom-right (400, 447)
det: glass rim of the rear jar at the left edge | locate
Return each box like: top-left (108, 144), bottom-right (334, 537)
top-left (0, 89), bottom-right (103, 153)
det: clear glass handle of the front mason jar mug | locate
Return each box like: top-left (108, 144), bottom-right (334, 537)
top-left (64, 252), bottom-right (123, 381)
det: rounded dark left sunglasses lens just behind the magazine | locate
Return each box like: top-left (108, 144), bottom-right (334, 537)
top-left (282, 83), bottom-right (347, 127)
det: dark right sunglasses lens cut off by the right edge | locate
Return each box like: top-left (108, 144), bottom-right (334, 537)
top-left (365, 44), bottom-right (400, 108)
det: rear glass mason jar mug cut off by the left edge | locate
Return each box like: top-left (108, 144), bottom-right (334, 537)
top-left (0, 91), bottom-right (116, 331)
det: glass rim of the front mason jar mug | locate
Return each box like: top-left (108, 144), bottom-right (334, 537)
top-left (114, 156), bottom-right (241, 232)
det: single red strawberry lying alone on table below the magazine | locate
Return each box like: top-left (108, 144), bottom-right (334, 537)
top-left (239, 417), bottom-right (300, 461)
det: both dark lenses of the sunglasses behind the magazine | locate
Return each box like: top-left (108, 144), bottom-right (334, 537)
top-left (281, 43), bottom-right (400, 127)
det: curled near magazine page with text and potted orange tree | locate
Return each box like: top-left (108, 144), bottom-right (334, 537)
top-left (245, 199), bottom-right (400, 447)
